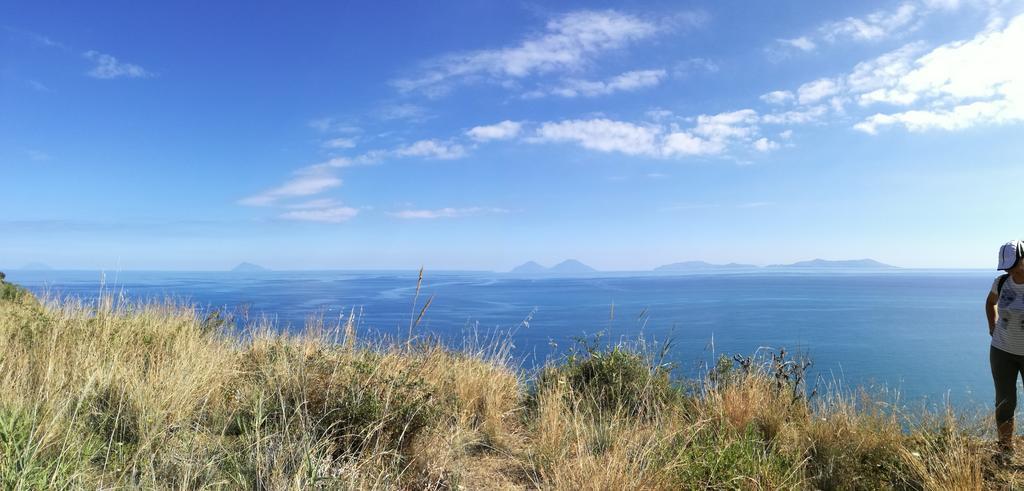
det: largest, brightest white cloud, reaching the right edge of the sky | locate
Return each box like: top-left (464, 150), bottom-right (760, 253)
top-left (761, 11), bottom-right (1024, 134)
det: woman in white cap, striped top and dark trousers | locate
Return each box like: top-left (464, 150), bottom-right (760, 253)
top-left (985, 240), bottom-right (1024, 460)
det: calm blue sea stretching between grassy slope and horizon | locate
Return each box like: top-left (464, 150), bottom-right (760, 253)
top-left (8, 271), bottom-right (995, 408)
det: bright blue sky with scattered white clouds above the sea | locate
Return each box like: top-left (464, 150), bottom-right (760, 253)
top-left (0, 0), bottom-right (1024, 271)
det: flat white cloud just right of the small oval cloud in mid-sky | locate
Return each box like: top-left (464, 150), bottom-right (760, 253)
top-left (531, 119), bottom-right (660, 155)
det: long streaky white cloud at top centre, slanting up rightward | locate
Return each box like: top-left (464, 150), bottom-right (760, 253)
top-left (392, 10), bottom-right (658, 95)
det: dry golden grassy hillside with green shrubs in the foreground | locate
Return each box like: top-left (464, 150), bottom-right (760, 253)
top-left (0, 286), bottom-right (1024, 489)
